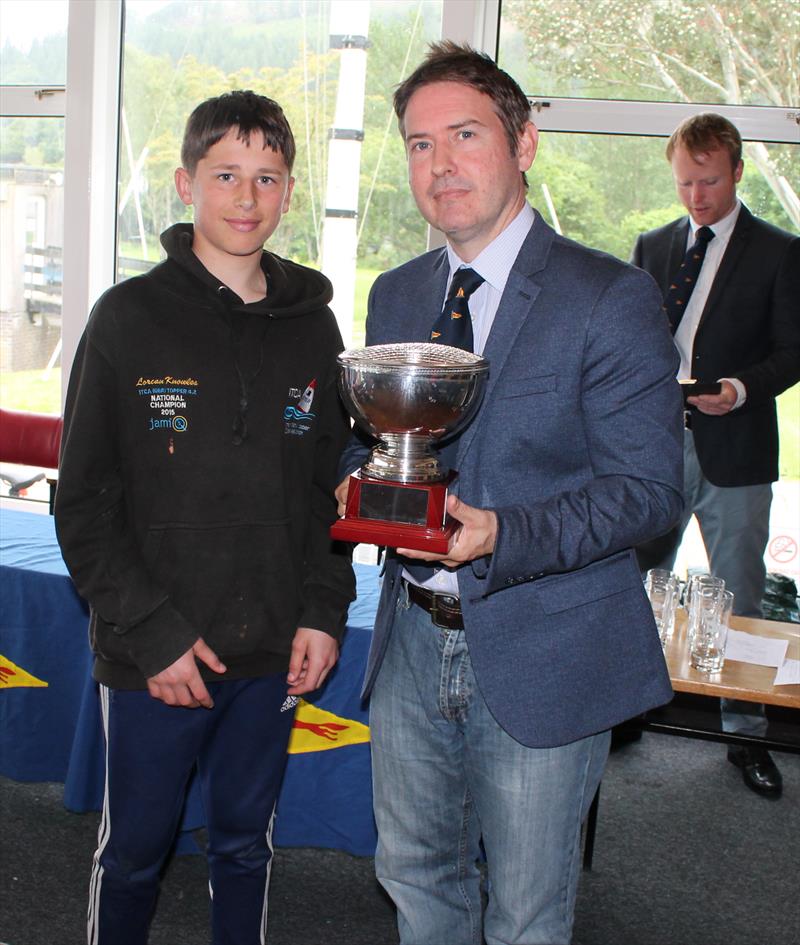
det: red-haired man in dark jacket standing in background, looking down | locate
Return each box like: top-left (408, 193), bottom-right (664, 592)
top-left (632, 113), bottom-right (800, 797)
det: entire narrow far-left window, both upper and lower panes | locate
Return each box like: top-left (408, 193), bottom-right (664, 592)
top-left (0, 0), bottom-right (67, 413)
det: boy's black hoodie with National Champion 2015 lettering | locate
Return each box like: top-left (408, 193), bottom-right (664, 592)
top-left (55, 224), bottom-right (354, 689)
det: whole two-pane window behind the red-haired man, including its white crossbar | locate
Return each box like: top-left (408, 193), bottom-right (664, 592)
top-left (499, 0), bottom-right (800, 251)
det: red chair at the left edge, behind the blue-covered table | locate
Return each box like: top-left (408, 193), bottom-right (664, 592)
top-left (0, 407), bottom-right (64, 513)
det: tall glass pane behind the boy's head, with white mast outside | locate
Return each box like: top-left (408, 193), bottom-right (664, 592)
top-left (118, 0), bottom-right (442, 344)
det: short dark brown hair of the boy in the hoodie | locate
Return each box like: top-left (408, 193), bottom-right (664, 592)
top-left (181, 90), bottom-right (296, 174)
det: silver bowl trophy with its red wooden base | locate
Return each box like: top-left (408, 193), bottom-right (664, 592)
top-left (332, 343), bottom-right (489, 551)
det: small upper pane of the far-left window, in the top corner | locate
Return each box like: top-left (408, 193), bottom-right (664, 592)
top-left (0, 0), bottom-right (68, 85)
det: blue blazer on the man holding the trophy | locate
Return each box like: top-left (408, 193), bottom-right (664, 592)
top-left (341, 214), bottom-right (683, 747)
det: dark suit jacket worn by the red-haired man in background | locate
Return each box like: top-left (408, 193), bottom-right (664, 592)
top-left (631, 206), bottom-right (800, 486)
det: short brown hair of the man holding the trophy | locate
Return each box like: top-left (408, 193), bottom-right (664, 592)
top-left (394, 40), bottom-right (531, 162)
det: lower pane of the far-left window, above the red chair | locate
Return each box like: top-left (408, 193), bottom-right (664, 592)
top-left (0, 118), bottom-right (64, 413)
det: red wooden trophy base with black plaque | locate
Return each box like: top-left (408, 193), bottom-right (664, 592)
top-left (331, 472), bottom-right (458, 554)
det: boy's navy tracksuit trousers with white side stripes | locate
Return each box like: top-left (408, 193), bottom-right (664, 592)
top-left (88, 674), bottom-right (295, 945)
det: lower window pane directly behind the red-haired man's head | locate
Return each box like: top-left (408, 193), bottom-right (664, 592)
top-left (528, 132), bottom-right (800, 259)
